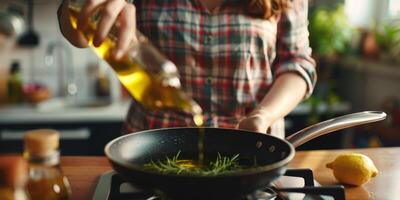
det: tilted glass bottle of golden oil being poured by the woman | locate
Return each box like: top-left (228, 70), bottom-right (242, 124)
top-left (69, 0), bottom-right (202, 120)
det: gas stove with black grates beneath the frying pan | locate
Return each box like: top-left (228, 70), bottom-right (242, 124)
top-left (93, 169), bottom-right (345, 200)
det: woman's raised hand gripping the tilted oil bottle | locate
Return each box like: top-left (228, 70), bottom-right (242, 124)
top-left (59, 0), bottom-right (136, 59)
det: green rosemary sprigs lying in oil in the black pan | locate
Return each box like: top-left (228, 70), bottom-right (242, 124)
top-left (144, 152), bottom-right (242, 176)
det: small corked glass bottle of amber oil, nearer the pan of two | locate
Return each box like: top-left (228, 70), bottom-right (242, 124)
top-left (24, 129), bottom-right (71, 200)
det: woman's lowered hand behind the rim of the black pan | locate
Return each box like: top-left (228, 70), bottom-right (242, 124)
top-left (237, 114), bottom-right (272, 134)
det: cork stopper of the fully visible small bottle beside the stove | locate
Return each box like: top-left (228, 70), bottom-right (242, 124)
top-left (24, 129), bottom-right (60, 155)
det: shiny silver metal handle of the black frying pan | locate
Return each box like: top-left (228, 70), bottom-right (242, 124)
top-left (286, 111), bottom-right (386, 147)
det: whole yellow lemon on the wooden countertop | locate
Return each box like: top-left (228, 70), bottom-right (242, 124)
top-left (326, 153), bottom-right (378, 186)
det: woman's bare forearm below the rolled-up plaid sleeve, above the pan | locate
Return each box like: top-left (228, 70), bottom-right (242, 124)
top-left (250, 73), bottom-right (307, 122)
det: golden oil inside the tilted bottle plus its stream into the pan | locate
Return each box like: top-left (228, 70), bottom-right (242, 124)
top-left (69, 6), bottom-right (205, 166)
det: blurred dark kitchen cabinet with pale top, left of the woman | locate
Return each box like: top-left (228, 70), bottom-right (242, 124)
top-left (0, 102), bottom-right (129, 155)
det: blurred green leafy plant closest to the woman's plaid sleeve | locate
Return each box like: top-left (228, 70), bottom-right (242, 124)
top-left (305, 3), bottom-right (350, 124)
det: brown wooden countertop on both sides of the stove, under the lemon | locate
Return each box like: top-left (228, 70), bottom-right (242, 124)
top-left (27, 147), bottom-right (400, 200)
